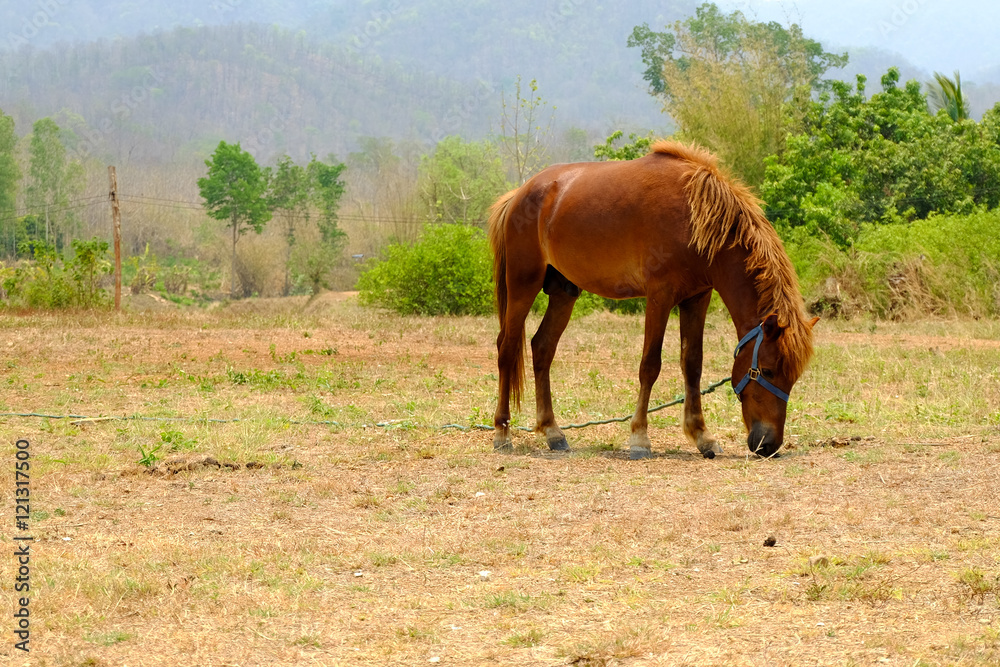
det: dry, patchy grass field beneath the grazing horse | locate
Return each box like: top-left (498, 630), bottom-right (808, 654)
top-left (0, 295), bottom-right (1000, 667)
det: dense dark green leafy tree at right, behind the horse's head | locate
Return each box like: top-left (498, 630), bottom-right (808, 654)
top-left (761, 68), bottom-right (1000, 248)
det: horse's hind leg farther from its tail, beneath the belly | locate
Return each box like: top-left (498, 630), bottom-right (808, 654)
top-left (531, 276), bottom-right (579, 450)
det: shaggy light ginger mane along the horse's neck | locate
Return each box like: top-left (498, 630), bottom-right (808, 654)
top-left (651, 141), bottom-right (813, 378)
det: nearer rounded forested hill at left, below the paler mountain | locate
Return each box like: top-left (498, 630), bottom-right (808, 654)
top-left (0, 25), bottom-right (494, 161)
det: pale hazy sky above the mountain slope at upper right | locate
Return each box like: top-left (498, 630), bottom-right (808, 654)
top-left (717, 0), bottom-right (1000, 80)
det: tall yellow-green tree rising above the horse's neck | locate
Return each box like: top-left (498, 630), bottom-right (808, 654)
top-left (628, 3), bottom-right (847, 185)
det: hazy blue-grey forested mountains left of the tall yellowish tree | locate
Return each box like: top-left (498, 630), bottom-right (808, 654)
top-left (0, 0), bottom-right (708, 160)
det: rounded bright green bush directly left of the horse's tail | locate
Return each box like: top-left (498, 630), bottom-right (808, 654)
top-left (358, 225), bottom-right (493, 315)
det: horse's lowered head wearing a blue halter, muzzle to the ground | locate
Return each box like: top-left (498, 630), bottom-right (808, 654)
top-left (733, 314), bottom-right (819, 457)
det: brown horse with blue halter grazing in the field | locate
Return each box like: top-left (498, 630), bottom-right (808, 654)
top-left (489, 141), bottom-right (816, 458)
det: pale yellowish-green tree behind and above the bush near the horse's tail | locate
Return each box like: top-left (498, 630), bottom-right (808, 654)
top-left (418, 136), bottom-right (508, 224)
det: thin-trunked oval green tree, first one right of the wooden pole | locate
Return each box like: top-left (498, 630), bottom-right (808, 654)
top-left (198, 141), bottom-right (271, 298)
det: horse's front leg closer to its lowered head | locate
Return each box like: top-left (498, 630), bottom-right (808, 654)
top-left (680, 291), bottom-right (722, 459)
